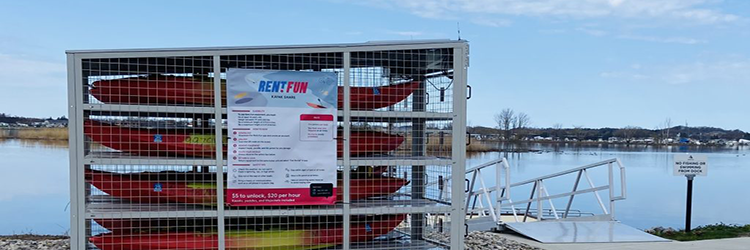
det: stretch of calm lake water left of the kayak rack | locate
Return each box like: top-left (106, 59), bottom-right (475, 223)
top-left (0, 140), bottom-right (70, 235)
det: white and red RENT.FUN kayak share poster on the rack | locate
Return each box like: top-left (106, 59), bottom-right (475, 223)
top-left (226, 69), bottom-right (338, 206)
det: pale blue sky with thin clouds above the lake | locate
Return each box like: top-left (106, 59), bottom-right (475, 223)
top-left (0, 0), bottom-right (750, 131)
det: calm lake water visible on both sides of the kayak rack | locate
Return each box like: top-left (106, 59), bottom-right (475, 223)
top-left (0, 140), bottom-right (750, 235)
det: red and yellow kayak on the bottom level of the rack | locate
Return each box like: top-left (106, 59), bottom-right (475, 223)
top-left (89, 214), bottom-right (406, 250)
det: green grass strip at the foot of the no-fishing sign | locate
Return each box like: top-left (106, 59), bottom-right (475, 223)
top-left (646, 223), bottom-right (750, 241)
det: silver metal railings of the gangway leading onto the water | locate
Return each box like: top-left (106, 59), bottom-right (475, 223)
top-left (465, 158), bottom-right (627, 224)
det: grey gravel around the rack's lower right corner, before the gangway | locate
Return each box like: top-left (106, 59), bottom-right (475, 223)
top-left (427, 232), bottom-right (543, 250)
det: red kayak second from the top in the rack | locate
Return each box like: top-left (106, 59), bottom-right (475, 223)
top-left (83, 120), bottom-right (404, 158)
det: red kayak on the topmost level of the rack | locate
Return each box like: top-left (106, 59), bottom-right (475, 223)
top-left (90, 75), bottom-right (419, 110)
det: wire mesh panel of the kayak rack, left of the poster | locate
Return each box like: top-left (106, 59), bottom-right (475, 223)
top-left (78, 56), bottom-right (219, 249)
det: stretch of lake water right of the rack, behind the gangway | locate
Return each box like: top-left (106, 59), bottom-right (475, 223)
top-left (467, 144), bottom-right (750, 229)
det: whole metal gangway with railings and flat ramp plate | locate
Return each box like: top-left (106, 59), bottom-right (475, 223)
top-left (465, 158), bottom-right (663, 243)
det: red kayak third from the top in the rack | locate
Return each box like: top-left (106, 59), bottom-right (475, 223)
top-left (85, 169), bottom-right (408, 205)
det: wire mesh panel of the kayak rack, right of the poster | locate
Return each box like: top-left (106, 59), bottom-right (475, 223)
top-left (349, 49), bottom-right (453, 249)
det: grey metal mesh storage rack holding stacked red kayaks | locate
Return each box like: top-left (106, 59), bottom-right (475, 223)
top-left (67, 40), bottom-right (470, 250)
